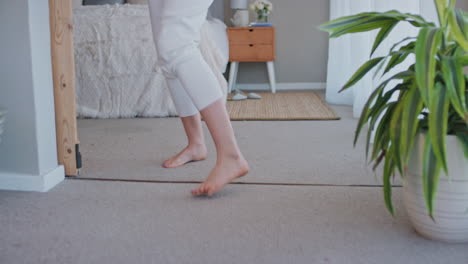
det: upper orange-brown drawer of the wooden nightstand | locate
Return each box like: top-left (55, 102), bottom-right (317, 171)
top-left (228, 27), bottom-right (275, 45)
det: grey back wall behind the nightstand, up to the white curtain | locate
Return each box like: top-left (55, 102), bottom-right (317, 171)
top-left (225, 0), bottom-right (330, 83)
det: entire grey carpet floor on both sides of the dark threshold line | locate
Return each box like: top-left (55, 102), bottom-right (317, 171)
top-left (0, 90), bottom-right (468, 264)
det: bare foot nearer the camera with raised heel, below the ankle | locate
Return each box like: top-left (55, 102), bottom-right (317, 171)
top-left (192, 157), bottom-right (249, 196)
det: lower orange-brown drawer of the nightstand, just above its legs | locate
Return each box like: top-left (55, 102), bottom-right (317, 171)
top-left (229, 44), bottom-right (275, 62)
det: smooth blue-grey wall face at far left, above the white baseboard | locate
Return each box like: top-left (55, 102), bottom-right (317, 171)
top-left (0, 0), bottom-right (38, 173)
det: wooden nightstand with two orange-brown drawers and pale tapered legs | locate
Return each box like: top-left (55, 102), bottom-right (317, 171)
top-left (227, 27), bottom-right (276, 93)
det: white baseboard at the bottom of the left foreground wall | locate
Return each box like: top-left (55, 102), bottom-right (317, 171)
top-left (0, 166), bottom-right (65, 192)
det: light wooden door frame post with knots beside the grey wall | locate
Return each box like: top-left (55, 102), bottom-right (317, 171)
top-left (49, 0), bottom-right (81, 176)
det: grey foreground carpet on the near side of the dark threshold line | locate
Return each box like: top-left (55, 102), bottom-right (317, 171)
top-left (0, 180), bottom-right (468, 264)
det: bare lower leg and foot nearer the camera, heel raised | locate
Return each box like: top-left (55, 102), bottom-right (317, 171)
top-left (192, 99), bottom-right (249, 195)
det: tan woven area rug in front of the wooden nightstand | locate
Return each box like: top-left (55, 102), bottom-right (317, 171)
top-left (227, 92), bottom-right (340, 120)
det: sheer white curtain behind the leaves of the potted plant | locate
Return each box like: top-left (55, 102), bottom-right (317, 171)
top-left (326, 0), bottom-right (437, 117)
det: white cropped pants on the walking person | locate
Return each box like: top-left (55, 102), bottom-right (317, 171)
top-left (149, 0), bottom-right (223, 117)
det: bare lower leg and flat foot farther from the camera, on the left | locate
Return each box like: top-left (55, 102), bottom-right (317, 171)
top-left (163, 114), bottom-right (207, 168)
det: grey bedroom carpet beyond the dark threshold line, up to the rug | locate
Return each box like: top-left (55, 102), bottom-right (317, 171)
top-left (78, 93), bottom-right (392, 185)
